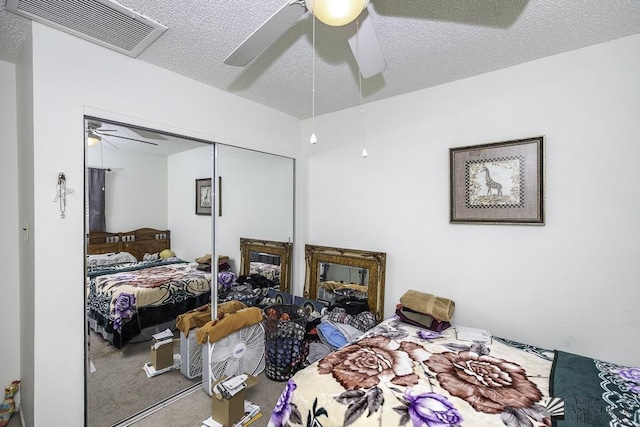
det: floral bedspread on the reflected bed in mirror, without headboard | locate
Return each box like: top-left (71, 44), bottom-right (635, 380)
top-left (87, 258), bottom-right (211, 348)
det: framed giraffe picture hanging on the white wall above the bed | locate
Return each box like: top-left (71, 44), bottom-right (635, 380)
top-left (449, 136), bottom-right (544, 225)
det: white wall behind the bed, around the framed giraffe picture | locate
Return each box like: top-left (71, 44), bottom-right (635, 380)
top-left (296, 36), bottom-right (640, 366)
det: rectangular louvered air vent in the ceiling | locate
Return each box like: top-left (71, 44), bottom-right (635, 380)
top-left (7, 0), bottom-right (167, 57)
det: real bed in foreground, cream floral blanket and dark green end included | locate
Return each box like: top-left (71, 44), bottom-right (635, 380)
top-left (269, 318), bottom-right (640, 427)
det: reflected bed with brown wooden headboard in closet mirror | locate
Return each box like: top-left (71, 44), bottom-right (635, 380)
top-left (86, 228), bottom-right (211, 349)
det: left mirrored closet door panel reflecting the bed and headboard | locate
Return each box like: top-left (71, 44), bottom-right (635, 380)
top-left (85, 118), bottom-right (213, 427)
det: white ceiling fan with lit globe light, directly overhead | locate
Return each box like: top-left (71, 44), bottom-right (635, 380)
top-left (223, 0), bottom-right (387, 78)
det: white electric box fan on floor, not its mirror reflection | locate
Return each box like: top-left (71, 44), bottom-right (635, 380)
top-left (202, 323), bottom-right (265, 395)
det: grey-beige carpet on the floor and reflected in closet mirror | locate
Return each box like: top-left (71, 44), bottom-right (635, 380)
top-left (86, 331), bottom-right (285, 427)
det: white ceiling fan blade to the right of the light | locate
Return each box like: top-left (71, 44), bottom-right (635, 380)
top-left (349, 8), bottom-right (387, 79)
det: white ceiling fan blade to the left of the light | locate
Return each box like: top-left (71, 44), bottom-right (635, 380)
top-left (223, 0), bottom-right (307, 67)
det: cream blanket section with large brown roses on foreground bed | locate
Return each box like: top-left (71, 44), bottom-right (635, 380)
top-left (269, 319), bottom-right (553, 427)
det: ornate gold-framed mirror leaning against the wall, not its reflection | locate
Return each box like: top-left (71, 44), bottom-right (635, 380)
top-left (304, 245), bottom-right (387, 322)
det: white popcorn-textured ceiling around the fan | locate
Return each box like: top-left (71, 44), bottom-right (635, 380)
top-left (0, 0), bottom-right (640, 119)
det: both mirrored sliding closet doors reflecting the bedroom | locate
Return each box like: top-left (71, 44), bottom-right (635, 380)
top-left (85, 117), bottom-right (294, 427)
